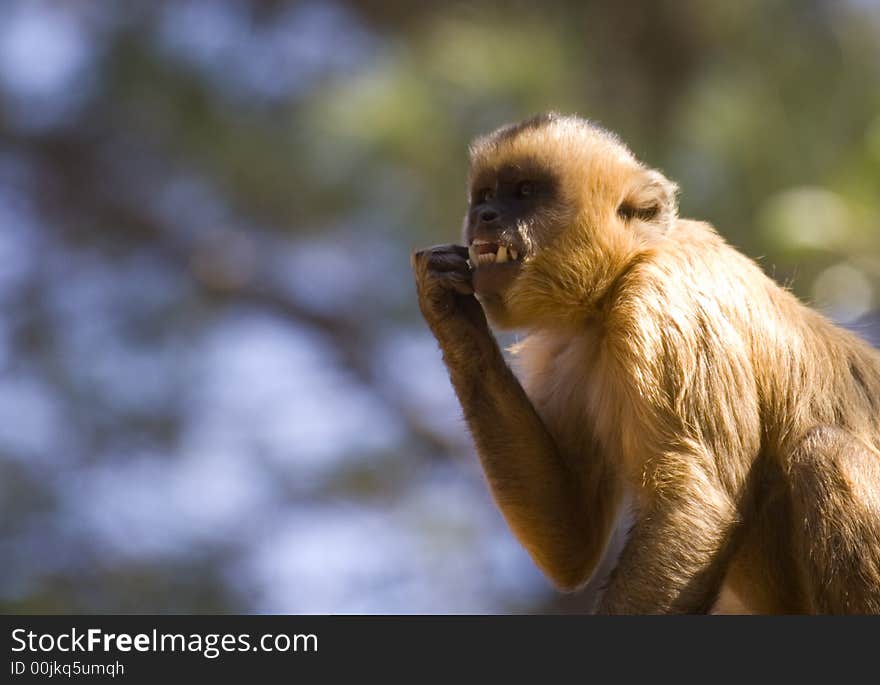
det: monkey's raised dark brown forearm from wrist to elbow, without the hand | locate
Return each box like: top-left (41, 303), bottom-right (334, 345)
top-left (438, 320), bottom-right (613, 589)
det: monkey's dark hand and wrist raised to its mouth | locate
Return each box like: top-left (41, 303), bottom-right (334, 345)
top-left (411, 245), bottom-right (492, 352)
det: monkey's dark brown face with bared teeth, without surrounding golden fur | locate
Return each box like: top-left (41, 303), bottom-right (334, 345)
top-left (463, 160), bottom-right (559, 297)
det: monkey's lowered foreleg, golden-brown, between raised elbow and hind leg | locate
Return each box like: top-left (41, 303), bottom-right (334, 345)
top-left (598, 456), bottom-right (737, 614)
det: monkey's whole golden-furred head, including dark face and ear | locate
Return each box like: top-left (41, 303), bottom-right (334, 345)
top-left (463, 112), bottom-right (677, 327)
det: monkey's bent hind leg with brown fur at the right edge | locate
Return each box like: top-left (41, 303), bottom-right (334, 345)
top-left (787, 427), bottom-right (880, 614)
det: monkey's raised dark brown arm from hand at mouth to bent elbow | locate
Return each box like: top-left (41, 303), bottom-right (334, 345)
top-left (412, 245), bottom-right (615, 589)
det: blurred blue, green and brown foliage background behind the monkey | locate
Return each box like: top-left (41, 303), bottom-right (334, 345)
top-left (0, 0), bottom-right (880, 613)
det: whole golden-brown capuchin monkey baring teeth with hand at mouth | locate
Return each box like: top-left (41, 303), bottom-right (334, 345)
top-left (412, 114), bottom-right (880, 614)
